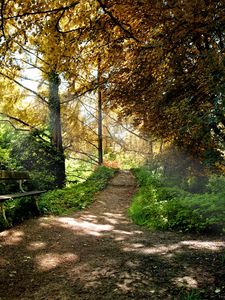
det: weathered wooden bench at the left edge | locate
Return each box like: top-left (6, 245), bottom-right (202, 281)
top-left (0, 170), bottom-right (46, 226)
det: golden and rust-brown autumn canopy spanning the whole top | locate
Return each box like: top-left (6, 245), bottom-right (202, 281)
top-left (0, 0), bottom-right (225, 180)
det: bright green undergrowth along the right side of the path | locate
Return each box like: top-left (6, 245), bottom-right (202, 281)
top-left (129, 168), bottom-right (225, 233)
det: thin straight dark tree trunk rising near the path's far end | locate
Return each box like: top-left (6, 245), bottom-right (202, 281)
top-left (98, 56), bottom-right (103, 165)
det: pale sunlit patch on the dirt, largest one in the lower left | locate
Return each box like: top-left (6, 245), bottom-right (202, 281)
top-left (35, 253), bottom-right (78, 271)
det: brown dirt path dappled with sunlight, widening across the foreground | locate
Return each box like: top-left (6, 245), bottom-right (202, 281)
top-left (0, 172), bottom-right (225, 300)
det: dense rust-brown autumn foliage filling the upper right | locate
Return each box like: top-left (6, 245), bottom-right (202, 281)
top-left (100, 0), bottom-right (225, 166)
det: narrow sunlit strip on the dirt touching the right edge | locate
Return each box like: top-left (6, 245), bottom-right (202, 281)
top-left (180, 241), bottom-right (225, 251)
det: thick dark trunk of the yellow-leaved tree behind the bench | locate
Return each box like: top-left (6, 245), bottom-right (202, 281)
top-left (49, 71), bottom-right (66, 188)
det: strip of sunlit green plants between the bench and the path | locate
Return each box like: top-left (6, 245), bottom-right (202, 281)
top-left (39, 166), bottom-right (115, 215)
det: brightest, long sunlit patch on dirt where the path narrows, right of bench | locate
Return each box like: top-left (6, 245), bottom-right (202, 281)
top-left (54, 218), bottom-right (114, 236)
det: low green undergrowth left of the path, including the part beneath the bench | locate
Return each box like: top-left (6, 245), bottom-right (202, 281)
top-left (0, 166), bottom-right (115, 230)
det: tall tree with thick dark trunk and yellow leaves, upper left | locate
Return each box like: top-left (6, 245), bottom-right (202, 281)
top-left (1, 1), bottom-right (100, 186)
